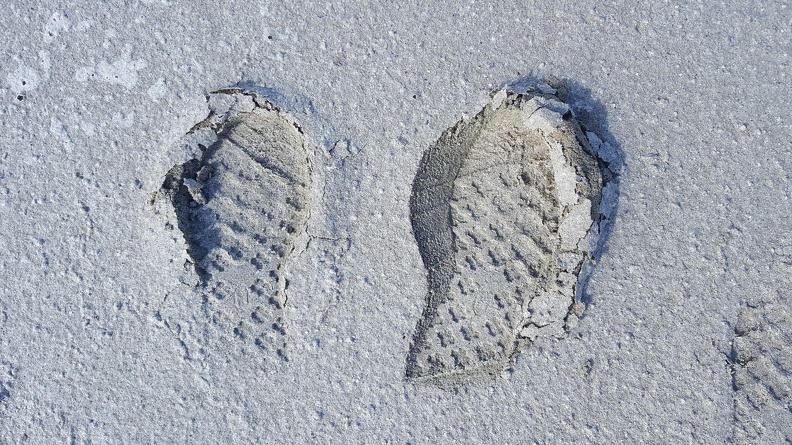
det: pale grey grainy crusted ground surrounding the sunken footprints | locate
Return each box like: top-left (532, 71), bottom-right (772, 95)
top-left (0, 0), bottom-right (792, 444)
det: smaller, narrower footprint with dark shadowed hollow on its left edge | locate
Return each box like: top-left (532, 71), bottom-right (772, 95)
top-left (160, 89), bottom-right (311, 360)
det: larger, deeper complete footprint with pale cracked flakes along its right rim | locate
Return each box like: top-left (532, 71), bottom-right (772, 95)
top-left (406, 84), bottom-right (603, 378)
